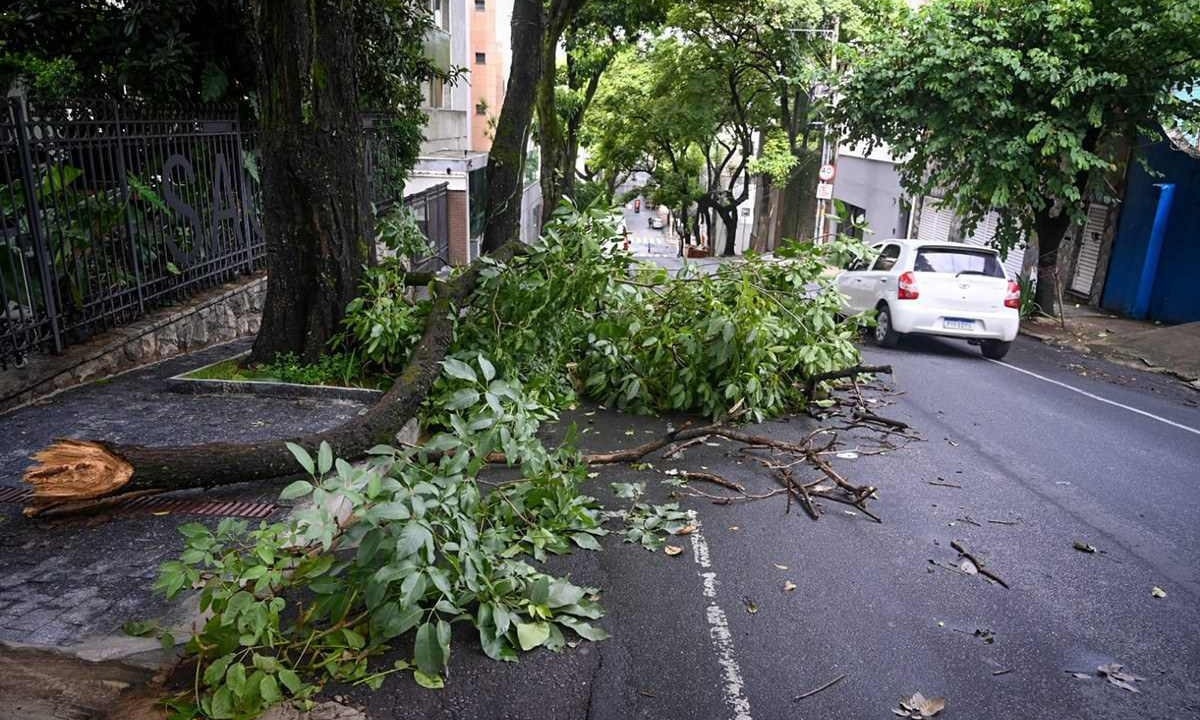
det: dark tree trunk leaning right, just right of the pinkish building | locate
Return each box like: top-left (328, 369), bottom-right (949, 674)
top-left (484, 0), bottom-right (548, 252)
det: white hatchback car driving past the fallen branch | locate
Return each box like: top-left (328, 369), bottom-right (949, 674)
top-left (836, 240), bottom-right (1021, 360)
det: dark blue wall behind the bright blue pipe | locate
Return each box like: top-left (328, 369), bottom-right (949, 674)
top-left (1100, 143), bottom-right (1200, 323)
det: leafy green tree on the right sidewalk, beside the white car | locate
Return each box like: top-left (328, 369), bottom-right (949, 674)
top-left (839, 0), bottom-right (1200, 311)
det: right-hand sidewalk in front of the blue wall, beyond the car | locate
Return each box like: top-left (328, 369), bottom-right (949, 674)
top-left (1021, 306), bottom-right (1200, 390)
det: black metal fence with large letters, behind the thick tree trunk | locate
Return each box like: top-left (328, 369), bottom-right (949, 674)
top-left (0, 98), bottom-right (432, 367)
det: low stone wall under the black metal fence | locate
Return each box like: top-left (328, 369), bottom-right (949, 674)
top-left (0, 275), bottom-right (266, 412)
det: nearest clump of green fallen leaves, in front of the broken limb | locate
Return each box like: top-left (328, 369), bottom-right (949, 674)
top-left (156, 356), bottom-right (606, 719)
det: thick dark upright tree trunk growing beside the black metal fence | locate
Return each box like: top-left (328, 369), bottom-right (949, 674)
top-left (251, 0), bottom-right (372, 361)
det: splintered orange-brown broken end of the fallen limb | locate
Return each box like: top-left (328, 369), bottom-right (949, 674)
top-left (25, 440), bottom-right (133, 508)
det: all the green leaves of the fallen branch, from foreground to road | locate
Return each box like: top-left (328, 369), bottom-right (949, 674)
top-left (150, 205), bottom-right (865, 719)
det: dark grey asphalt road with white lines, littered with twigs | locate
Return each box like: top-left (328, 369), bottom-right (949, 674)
top-left (343, 338), bottom-right (1200, 720)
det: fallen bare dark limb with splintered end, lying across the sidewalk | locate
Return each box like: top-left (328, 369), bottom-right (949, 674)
top-left (25, 240), bottom-right (526, 516)
